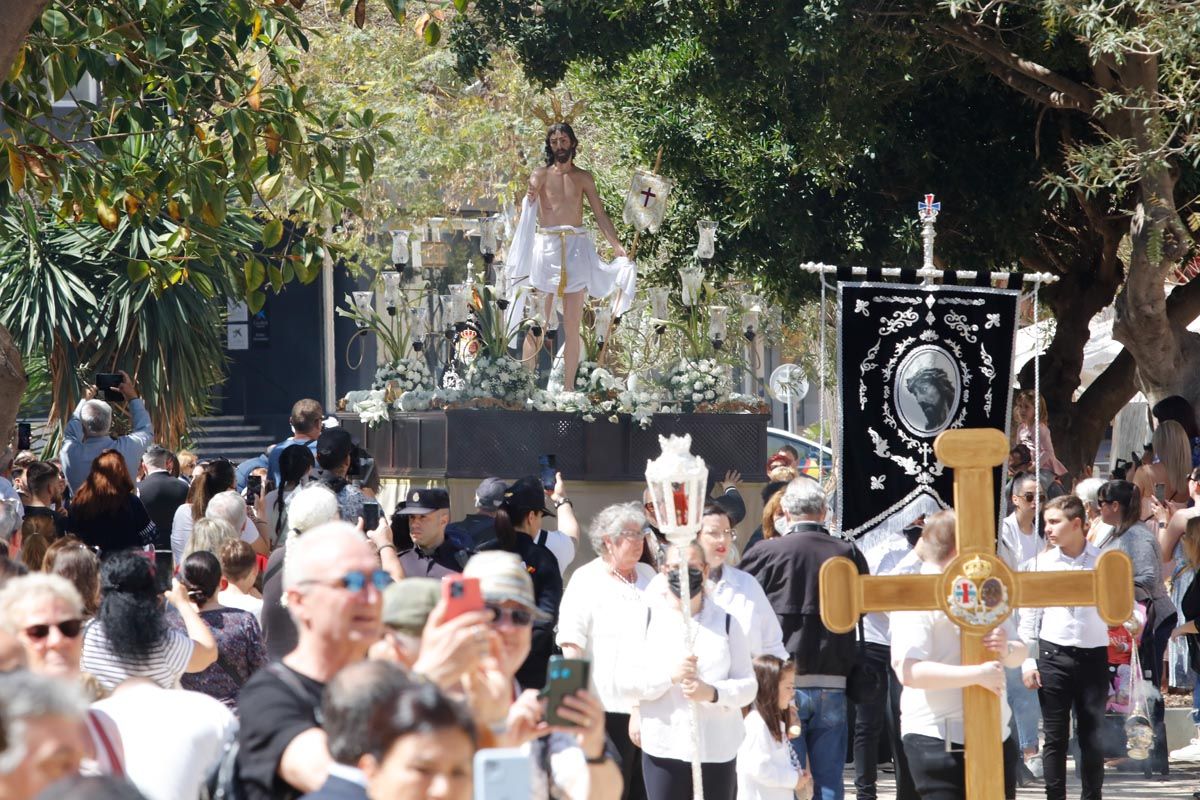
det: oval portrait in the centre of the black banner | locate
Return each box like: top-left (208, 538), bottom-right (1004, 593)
top-left (892, 344), bottom-right (962, 437)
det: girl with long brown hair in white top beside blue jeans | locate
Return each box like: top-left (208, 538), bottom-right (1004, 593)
top-left (738, 655), bottom-right (812, 800)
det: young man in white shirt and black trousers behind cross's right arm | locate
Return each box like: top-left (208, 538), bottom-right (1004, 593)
top-left (1020, 495), bottom-right (1141, 800)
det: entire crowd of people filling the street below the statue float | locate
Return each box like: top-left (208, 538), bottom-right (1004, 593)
top-left (0, 375), bottom-right (1200, 800)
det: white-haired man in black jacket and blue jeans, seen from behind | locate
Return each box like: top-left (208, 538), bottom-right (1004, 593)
top-left (738, 475), bottom-right (868, 800)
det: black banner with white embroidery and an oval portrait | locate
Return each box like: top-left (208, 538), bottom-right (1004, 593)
top-left (838, 283), bottom-right (1019, 537)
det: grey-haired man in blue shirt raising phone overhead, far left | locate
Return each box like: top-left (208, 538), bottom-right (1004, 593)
top-left (61, 372), bottom-right (154, 492)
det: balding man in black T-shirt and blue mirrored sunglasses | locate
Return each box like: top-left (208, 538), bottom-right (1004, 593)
top-left (238, 522), bottom-right (391, 800)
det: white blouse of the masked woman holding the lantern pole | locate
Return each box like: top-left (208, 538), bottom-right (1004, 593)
top-left (618, 585), bottom-right (757, 764)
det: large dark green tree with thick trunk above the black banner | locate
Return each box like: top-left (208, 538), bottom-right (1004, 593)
top-left (451, 0), bottom-right (1200, 467)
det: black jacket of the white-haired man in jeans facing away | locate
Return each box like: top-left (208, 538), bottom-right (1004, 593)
top-left (738, 522), bottom-right (869, 678)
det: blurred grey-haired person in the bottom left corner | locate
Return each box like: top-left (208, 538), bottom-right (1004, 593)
top-left (0, 672), bottom-right (88, 800)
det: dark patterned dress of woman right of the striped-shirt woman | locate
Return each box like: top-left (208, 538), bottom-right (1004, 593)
top-left (167, 606), bottom-right (266, 711)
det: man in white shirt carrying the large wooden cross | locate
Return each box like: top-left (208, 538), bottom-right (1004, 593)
top-left (890, 511), bottom-right (1027, 798)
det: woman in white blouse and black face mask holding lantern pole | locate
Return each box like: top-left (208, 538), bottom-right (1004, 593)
top-left (618, 543), bottom-right (757, 800)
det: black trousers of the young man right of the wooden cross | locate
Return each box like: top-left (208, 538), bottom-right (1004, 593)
top-left (1038, 639), bottom-right (1109, 800)
